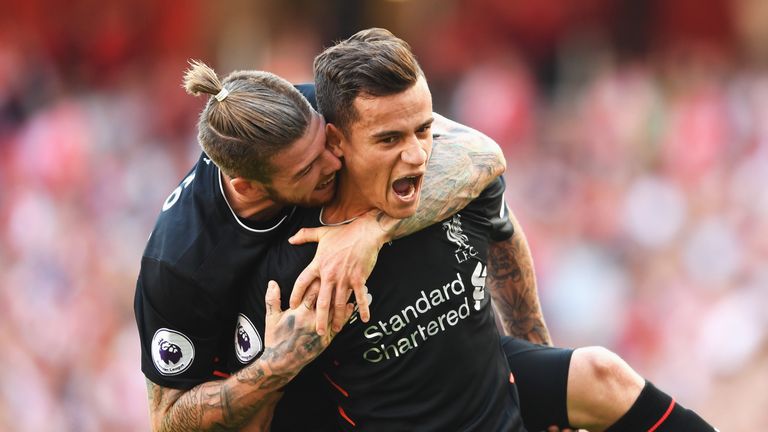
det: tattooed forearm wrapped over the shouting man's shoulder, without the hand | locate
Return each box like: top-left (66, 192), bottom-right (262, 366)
top-left (379, 115), bottom-right (505, 238)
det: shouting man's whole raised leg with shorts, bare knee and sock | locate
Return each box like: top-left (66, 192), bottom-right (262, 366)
top-left (502, 336), bottom-right (715, 432)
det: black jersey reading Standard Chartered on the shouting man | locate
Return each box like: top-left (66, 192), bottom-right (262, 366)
top-left (241, 180), bottom-right (524, 431)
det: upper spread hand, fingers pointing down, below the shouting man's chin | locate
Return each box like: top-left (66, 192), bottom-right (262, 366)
top-left (288, 210), bottom-right (389, 335)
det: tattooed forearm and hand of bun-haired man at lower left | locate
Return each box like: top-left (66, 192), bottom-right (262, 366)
top-left (147, 282), bottom-right (352, 432)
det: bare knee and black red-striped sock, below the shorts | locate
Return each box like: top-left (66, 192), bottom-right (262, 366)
top-left (568, 347), bottom-right (715, 432)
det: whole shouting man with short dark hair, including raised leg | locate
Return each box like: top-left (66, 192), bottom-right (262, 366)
top-left (236, 29), bottom-right (714, 431)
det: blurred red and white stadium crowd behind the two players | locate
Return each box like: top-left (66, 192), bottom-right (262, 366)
top-left (0, 0), bottom-right (768, 432)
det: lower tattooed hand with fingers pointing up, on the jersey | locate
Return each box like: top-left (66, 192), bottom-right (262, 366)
top-left (262, 281), bottom-right (354, 374)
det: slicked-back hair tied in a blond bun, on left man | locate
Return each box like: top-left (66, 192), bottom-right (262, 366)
top-left (184, 61), bottom-right (312, 184)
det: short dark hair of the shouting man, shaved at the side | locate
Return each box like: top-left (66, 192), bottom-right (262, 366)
top-left (314, 28), bottom-right (424, 131)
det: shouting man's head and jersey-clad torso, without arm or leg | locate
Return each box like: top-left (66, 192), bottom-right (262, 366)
top-left (241, 29), bottom-right (524, 431)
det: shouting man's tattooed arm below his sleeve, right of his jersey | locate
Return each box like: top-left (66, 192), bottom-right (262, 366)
top-left (485, 208), bottom-right (552, 345)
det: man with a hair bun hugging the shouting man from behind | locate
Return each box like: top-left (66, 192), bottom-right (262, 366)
top-left (134, 59), bottom-right (504, 431)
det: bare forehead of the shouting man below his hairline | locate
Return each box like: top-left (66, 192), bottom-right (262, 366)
top-left (350, 77), bottom-right (432, 133)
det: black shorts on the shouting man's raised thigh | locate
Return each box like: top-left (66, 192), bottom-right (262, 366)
top-left (501, 336), bottom-right (573, 432)
